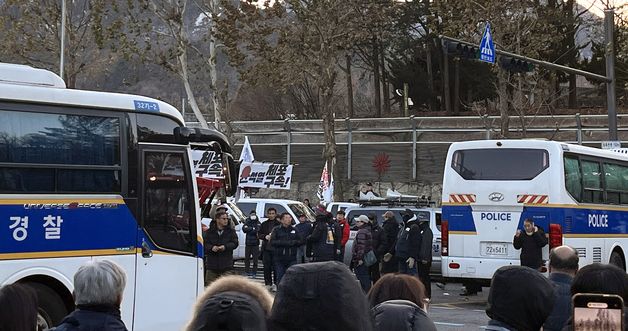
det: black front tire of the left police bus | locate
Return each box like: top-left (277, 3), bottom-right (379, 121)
top-left (25, 282), bottom-right (69, 330)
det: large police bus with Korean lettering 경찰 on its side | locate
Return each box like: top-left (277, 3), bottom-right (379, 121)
top-left (0, 64), bottom-right (235, 330)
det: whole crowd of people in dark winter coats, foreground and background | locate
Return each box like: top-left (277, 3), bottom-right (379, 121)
top-left (0, 208), bottom-right (628, 331)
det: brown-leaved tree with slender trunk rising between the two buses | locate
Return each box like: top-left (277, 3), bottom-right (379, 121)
top-left (219, 0), bottom-right (372, 200)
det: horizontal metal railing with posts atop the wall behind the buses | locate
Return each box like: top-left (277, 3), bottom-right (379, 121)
top-left (188, 114), bottom-right (628, 180)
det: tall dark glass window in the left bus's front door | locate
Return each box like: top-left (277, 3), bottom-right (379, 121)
top-left (144, 152), bottom-right (196, 253)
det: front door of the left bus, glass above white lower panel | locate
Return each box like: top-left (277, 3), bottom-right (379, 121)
top-left (133, 148), bottom-right (203, 331)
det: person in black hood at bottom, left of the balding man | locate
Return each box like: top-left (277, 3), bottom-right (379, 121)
top-left (486, 266), bottom-right (556, 331)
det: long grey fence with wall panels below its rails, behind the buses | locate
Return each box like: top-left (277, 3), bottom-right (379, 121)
top-left (190, 114), bottom-right (628, 184)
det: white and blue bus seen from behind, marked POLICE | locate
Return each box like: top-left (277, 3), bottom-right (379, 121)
top-left (441, 140), bottom-right (628, 285)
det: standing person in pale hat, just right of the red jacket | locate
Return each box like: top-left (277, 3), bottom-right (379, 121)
top-left (351, 215), bottom-right (373, 292)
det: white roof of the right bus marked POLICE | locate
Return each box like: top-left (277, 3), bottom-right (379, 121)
top-left (450, 139), bottom-right (628, 160)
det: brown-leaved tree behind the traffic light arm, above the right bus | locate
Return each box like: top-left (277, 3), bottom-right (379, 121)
top-left (435, 0), bottom-right (560, 137)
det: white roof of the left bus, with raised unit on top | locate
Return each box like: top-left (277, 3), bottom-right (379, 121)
top-left (0, 63), bottom-right (184, 125)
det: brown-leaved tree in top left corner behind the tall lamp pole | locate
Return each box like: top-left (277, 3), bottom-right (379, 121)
top-left (0, 0), bottom-right (113, 88)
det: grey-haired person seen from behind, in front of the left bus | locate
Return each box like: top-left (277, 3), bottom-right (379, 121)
top-left (52, 260), bottom-right (127, 331)
